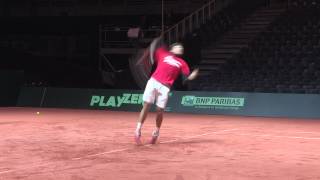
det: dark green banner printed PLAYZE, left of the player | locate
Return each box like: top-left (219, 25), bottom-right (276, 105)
top-left (43, 88), bottom-right (143, 111)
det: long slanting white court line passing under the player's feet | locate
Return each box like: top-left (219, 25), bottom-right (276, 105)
top-left (0, 129), bottom-right (238, 175)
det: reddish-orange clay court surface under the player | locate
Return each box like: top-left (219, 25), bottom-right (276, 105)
top-left (0, 108), bottom-right (320, 180)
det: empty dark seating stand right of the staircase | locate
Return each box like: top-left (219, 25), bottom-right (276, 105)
top-left (195, 4), bottom-right (320, 94)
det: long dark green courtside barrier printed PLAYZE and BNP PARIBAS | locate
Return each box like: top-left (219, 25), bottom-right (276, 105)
top-left (18, 88), bottom-right (320, 118)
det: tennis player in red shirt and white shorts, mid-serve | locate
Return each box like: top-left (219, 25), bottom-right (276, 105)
top-left (135, 38), bottom-right (199, 145)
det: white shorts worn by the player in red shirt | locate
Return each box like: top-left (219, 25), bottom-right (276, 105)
top-left (143, 78), bottom-right (170, 109)
